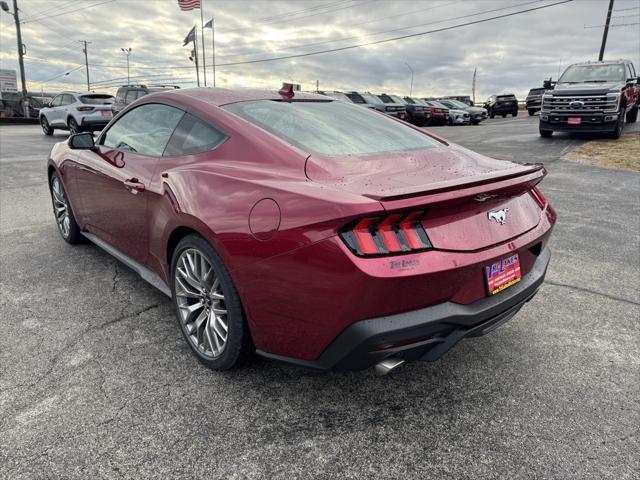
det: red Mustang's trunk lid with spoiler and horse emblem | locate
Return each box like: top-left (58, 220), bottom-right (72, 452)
top-left (306, 145), bottom-right (546, 251)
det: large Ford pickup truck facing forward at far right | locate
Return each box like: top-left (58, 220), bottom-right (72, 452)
top-left (540, 60), bottom-right (640, 138)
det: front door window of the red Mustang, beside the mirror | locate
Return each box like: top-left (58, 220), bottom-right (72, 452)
top-left (100, 103), bottom-right (184, 157)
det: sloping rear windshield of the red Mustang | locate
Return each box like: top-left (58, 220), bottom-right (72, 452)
top-left (223, 100), bottom-right (441, 156)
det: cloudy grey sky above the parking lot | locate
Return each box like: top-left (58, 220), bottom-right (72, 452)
top-left (0, 0), bottom-right (640, 100)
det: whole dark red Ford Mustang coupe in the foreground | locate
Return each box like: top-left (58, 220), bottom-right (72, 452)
top-left (48, 89), bottom-right (556, 372)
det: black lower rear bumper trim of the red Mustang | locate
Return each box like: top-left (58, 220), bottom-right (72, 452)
top-left (258, 247), bottom-right (551, 371)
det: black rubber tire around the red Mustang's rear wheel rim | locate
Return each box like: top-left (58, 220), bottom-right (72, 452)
top-left (171, 234), bottom-right (254, 370)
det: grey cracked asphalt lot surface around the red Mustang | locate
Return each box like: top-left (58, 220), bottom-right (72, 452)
top-left (0, 117), bottom-right (640, 480)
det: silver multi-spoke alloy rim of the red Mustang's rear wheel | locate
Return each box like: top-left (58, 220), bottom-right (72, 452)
top-left (173, 248), bottom-right (229, 359)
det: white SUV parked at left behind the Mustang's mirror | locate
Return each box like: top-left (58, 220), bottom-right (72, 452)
top-left (39, 92), bottom-right (114, 135)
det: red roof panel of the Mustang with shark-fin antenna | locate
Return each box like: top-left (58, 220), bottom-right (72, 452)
top-left (165, 88), bottom-right (333, 107)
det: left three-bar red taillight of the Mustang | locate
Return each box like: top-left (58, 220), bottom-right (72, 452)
top-left (340, 211), bottom-right (432, 256)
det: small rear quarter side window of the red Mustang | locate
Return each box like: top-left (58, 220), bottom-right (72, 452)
top-left (164, 113), bottom-right (227, 157)
